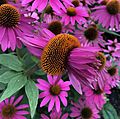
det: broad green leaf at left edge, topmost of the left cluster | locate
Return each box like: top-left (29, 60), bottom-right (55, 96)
top-left (0, 54), bottom-right (23, 71)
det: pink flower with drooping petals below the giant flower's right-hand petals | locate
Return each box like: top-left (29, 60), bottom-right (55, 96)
top-left (83, 82), bottom-right (111, 109)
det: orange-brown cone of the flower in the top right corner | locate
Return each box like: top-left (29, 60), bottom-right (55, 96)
top-left (106, 0), bottom-right (120, 15)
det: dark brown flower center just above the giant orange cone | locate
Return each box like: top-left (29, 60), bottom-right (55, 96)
top-left (48, 21), bottom-right (62, 35)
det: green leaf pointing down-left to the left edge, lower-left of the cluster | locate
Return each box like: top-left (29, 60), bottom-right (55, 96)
top-left (0, 74), bottom-right (27, 102)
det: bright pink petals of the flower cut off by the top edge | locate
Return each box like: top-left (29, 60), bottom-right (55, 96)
top-left (22, 0), bottom-right (70, 12)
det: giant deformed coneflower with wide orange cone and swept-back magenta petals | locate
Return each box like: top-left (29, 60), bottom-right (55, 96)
top-left (23, 29), bottom-right (99, 94)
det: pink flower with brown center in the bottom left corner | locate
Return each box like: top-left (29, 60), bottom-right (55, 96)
top-left (0, 96), bottom-right (29, 119)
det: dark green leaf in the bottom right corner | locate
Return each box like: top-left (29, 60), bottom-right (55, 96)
top-left (102, 102), bottom-right (118, 119)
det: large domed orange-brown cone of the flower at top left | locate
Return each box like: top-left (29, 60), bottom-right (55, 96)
top-left (0, 4), bottom-right (20, 27)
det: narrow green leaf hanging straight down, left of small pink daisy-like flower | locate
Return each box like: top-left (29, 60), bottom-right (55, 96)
top-left (25, 80), bottom-right (39, 118)
